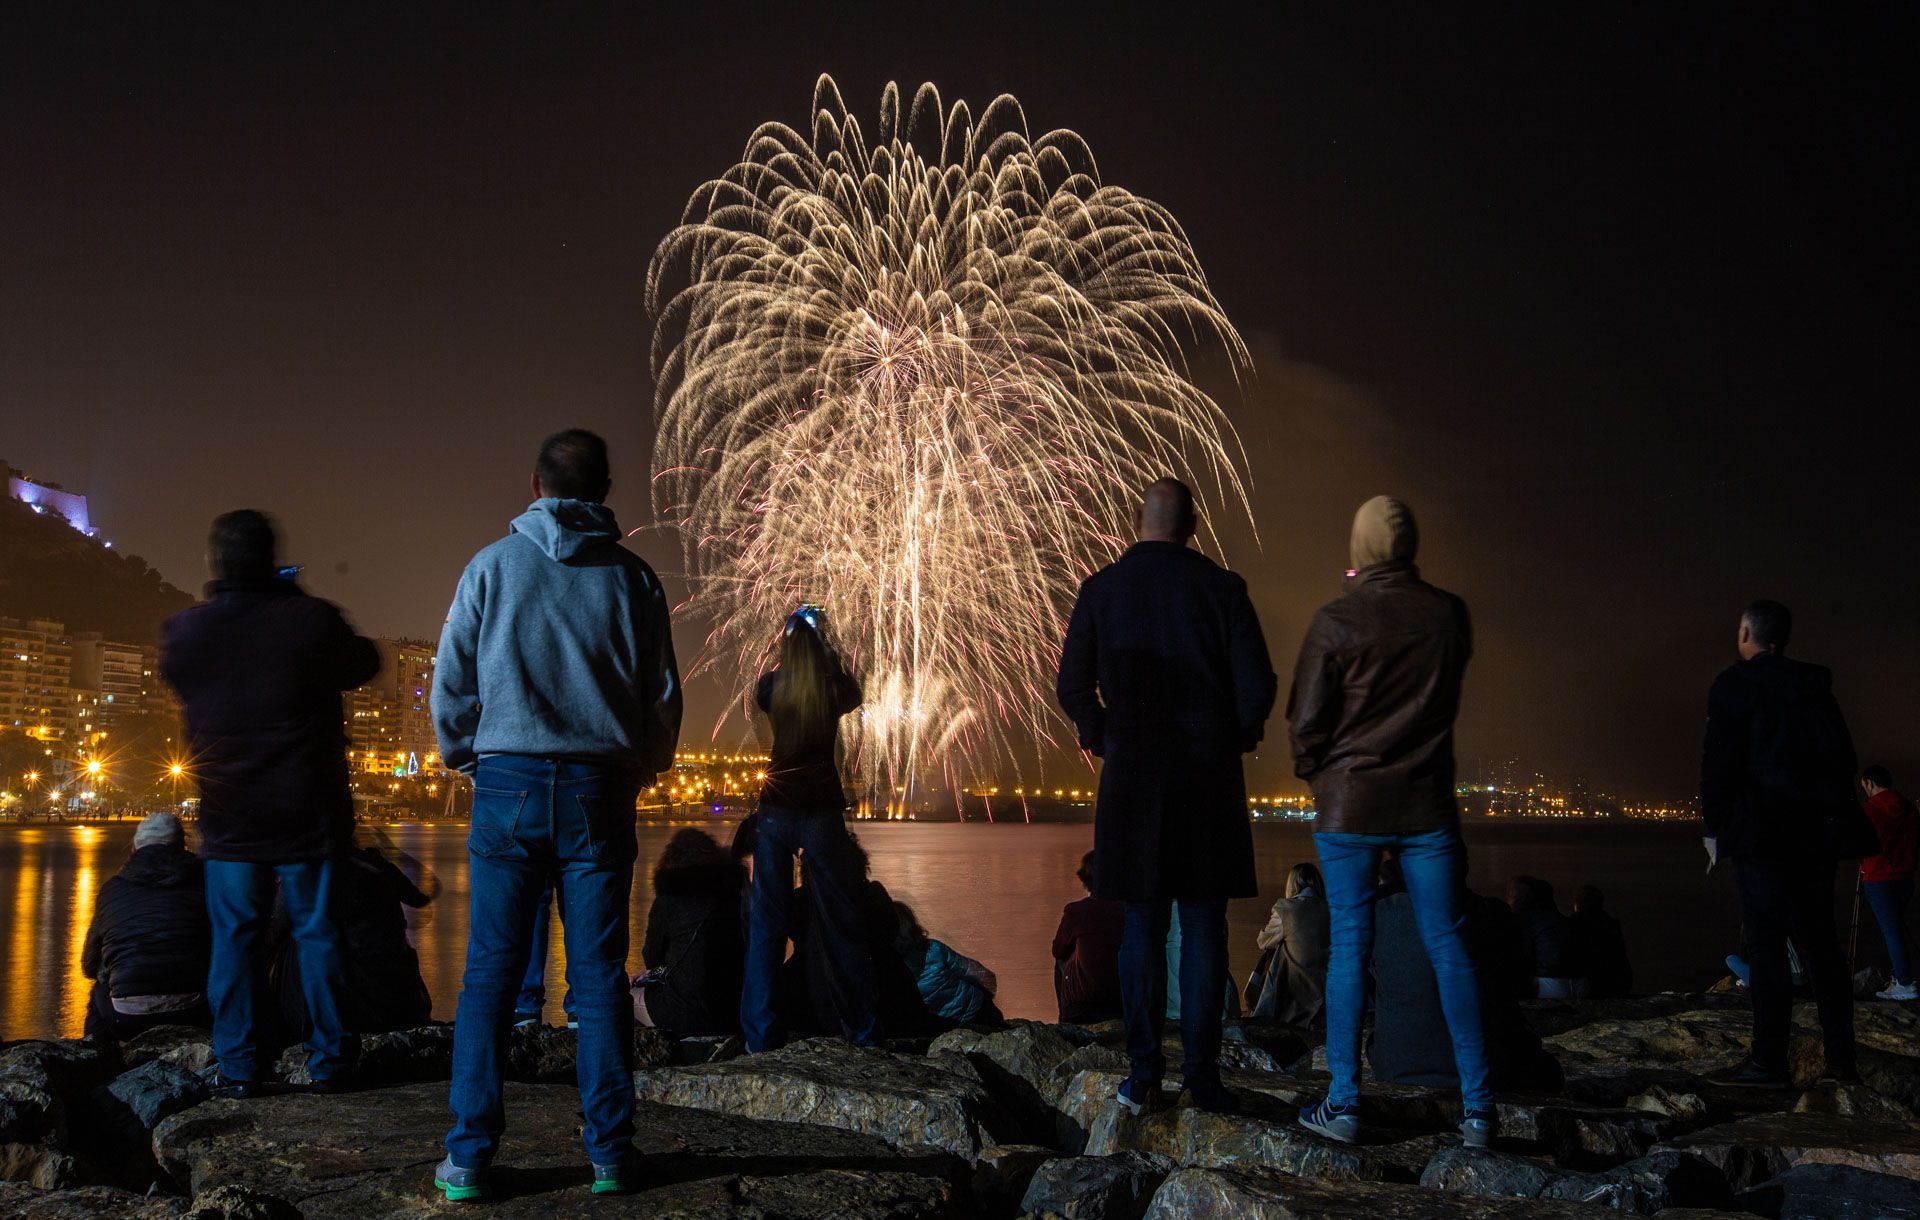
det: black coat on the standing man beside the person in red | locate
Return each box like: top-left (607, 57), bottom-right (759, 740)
top-left (1699, 653), bottom-right (1864, 859)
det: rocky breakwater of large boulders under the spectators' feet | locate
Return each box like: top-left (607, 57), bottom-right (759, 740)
top-left (0, 995), bottom-right (1920, 1220)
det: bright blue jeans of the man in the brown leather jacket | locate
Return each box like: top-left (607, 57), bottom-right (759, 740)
top-left (1313, 830), bottom-right (1494, 1110)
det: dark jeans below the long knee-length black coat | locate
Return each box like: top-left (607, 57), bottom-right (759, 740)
top-left (1119, 899), bottom-right (1227, 1087)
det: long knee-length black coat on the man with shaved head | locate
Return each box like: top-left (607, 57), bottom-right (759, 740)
top-left (1058, 542), bottom-right (1277, 899)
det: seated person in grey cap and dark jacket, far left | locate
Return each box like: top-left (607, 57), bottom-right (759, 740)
top-left (81, 813), bottom-right (213, 1039)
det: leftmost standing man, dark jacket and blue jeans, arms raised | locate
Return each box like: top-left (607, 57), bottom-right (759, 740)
top-left (159, 509), bottom-right (380, 1097)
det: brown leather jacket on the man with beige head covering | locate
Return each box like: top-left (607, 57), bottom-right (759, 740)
top-left (1286, 563), bottom-right (1473, 834)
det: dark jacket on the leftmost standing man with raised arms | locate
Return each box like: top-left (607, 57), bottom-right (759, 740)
top-left (159, 580), bottom-right (380, 863)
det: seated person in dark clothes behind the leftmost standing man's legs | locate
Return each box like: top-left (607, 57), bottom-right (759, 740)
top-left (273, 826), bottom-right (438, 1039)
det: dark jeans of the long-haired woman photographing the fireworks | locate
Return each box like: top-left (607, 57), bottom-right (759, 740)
top-left (739, 805), bottom-right (879, 1051)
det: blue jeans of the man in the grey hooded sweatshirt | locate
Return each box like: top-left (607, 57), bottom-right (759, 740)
top-left (447, 755), bottom-right (639, 1168)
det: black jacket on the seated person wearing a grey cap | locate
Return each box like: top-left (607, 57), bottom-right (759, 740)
top-left (81, 843), bottom-right (213, 999)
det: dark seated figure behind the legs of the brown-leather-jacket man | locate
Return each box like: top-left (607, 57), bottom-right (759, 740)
top-left (1367, 863), bottom-right (1565, 1091)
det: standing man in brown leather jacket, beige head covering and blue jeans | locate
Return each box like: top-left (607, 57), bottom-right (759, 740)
top-left (1286, 496), bottom-right (1496, 1147)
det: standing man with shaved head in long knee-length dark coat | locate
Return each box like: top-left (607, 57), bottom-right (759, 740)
top-left (1058, 478), bottom-right (1275, 1112)
